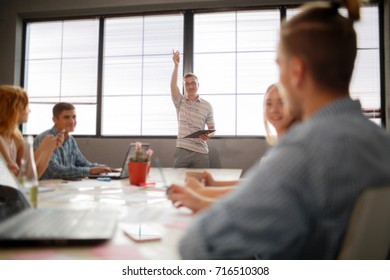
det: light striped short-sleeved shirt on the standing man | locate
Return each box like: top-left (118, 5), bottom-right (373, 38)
top-left (172, 94), bottom-right (215, 154)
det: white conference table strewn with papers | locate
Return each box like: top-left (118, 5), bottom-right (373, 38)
top-left (0, 168), bottom-right (242, 260)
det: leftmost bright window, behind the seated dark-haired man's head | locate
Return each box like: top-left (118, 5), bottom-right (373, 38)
top-left (24, 19), bottom-right (99, 135)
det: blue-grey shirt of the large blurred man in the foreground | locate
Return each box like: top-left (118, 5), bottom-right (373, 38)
top-left (180, 98), bottom-right (390, 259)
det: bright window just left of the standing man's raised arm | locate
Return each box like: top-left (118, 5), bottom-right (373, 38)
top-left (102, 14), bottom-right (184, 136)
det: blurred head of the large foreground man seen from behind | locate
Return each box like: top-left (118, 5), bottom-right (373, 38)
top-left (277, 2), bottom-right (357, 119)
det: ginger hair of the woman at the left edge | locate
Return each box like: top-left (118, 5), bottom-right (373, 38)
top-left (0, 85), bottom-right (28, 139)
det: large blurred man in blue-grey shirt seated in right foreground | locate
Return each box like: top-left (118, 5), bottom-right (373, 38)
top-left (180, 2), bottom-right (390, 259)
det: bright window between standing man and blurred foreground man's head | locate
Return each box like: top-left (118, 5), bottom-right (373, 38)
top-left (194, 9), bottom-right (280, 136)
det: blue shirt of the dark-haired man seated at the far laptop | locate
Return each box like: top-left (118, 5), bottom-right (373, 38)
top-left (34, 127), bottom-right (101, 180)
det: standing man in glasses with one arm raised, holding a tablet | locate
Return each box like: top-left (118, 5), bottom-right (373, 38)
top-left (171, 51), bottom-right (215, 168)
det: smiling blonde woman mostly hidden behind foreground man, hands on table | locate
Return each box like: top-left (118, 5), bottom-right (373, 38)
top-left (168, 84), bottom-right (294, 212)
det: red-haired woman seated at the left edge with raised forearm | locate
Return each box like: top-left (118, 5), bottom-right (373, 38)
top-left (0, 85), bottom-right (64, 177)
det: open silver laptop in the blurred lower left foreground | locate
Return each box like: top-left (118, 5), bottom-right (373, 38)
top-left (0, 156), bottom-right (118, 247)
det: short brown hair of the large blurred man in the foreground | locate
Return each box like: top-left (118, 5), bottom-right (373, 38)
top-left (280, 3), bottom-right (357, 92)
